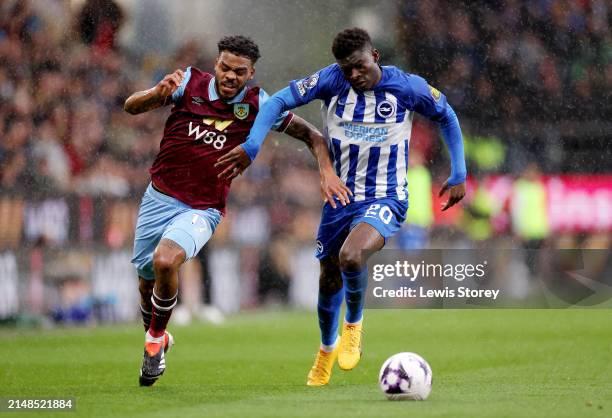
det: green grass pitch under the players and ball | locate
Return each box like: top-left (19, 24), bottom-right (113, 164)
top-left (0, 309), bottom-right (612, 418)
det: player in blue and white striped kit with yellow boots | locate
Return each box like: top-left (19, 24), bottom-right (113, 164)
top-left (219, 28), bottom-right (466, 386)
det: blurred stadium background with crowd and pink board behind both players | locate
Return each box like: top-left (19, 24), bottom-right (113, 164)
top-left (0, 0), bottom-right (612, 324)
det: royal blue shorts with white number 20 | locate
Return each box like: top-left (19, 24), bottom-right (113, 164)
top-left (315, 197), bottom-right (408, 260)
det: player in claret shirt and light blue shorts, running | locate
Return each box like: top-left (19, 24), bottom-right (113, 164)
top-left (124, 36), bottom-right (349, 386)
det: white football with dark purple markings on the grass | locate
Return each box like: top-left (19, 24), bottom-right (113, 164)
top-left (378, 353), bottom-right (432, 401)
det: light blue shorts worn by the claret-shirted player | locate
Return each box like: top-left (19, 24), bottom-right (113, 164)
top-left (132, 184), bottom-right (221, 280)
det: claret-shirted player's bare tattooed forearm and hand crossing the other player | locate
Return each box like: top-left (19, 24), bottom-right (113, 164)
top-left (285, 115), bottom-right (353, 209)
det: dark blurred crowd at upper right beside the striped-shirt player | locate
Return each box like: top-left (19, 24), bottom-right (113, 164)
top-left (400, 0), bottom-right (612, 125)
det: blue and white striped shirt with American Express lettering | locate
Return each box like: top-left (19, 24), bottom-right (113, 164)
top-left (290, 64), bottom-right (446, 202)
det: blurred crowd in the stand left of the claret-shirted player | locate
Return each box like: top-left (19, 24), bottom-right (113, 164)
top-left (0, 1), bottom-right (149, 196)
